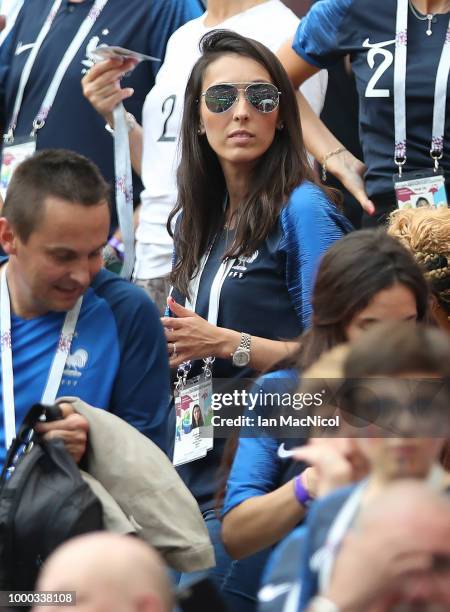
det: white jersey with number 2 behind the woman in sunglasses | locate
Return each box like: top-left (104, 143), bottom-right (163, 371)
top-left (134, 0), bottom-right (328, 279)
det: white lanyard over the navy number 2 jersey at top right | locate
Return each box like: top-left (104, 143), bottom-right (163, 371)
top-left (394, 0), bottom-right (450, 177)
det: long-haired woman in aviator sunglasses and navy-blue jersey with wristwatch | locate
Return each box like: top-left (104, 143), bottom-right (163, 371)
top-left (162, 30), bottom-right (350, 609)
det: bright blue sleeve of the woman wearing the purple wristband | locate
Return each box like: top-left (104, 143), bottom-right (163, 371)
top-left (223, 370), bottom-right (298, 514)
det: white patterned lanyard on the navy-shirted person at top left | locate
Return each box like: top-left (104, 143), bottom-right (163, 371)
top-left (4, 0), bottom-right (108, 144)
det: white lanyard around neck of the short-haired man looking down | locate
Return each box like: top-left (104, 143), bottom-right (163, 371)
top-left (0, 264), bottom-right (83, 449)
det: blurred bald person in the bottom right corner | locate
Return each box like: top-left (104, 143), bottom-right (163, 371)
top-left (308, 481), bottom-right (450, 612)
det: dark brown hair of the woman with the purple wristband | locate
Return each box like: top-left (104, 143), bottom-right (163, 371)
top-left (296, 229), bottom-right (429, 369)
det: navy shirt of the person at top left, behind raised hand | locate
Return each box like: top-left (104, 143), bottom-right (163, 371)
top-left (0, 0), bottom-right (203, 221)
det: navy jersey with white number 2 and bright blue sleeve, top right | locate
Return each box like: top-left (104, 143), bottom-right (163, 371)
top-left (293, 0), bottom-right (450, 196)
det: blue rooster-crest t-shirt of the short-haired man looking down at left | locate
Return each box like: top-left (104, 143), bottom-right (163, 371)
top-left (0, 270), bottom-right (170, 465)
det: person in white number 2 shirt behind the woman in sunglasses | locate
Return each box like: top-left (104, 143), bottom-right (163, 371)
top-left (82, 0), bottom-right (327, 313)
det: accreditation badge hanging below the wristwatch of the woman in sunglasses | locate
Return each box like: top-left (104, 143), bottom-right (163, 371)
top-left (173, 374), bottom-right (214, 466)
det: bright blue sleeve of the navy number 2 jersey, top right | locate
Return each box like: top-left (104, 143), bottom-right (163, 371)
top-left (292, 0), bottom-right (354, 68)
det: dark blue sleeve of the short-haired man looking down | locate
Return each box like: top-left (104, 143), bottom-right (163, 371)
top-left (93, 271), bottom-right (171, 452)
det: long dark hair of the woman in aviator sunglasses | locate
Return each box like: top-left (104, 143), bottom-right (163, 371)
top-left (167, 30), bottom-right (315, 296)
